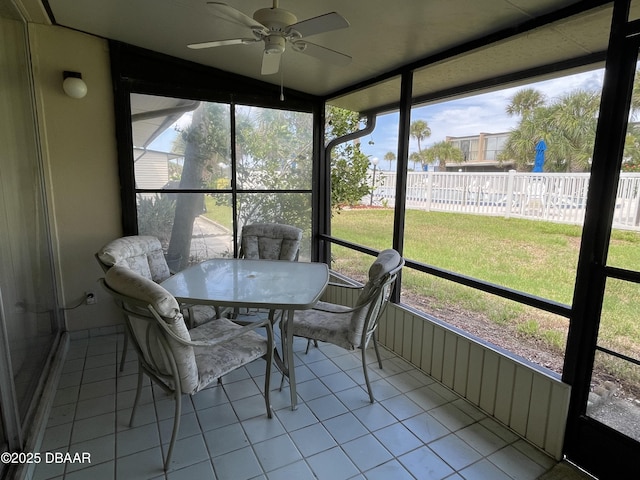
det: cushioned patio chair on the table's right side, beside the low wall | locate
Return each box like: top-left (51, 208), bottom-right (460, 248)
top-left (288, 249), bottom-right (404, 403)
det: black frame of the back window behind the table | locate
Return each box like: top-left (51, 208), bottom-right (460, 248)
top-left (109, 41), bottom-right (324, 260)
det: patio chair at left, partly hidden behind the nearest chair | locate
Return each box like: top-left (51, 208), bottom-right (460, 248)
top-left (95, 235), bottom-right (220, 371)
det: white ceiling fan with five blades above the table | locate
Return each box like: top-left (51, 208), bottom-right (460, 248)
top-left (187, 0), bottom-right (351, 75)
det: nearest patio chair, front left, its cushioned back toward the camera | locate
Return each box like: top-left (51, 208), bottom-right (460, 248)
top-left (100, 266), bottom-right (273, 470)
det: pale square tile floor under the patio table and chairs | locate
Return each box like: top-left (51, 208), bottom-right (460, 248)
top-left (33, 334), bottom-right (592, 480)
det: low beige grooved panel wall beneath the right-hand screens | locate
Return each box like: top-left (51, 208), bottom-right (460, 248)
top-left (324, 286), bottom-right (571, 460)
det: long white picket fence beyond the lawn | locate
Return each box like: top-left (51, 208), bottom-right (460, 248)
top-left (368, 171), bottom-right (640, 231)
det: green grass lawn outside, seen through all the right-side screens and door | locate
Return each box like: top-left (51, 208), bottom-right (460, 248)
top-left (332, 209), bottom-right (640, 356)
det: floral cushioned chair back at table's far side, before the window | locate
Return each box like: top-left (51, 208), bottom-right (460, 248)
top-left (240, 223), bottom-right (302, 261)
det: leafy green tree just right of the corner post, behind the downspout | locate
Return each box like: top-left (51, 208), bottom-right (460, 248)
top-left (325, 106), bottom-right (371, 210)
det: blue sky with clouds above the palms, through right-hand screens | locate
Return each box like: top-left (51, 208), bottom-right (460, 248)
top-left (360, 70), bottom-right (604, 170)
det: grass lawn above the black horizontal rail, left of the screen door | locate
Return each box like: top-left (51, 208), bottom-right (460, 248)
top-left (332, 209), bottom-right (588, 304)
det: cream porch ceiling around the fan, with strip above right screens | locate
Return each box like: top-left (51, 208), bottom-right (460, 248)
top-left (38, 0), bottom-right (611, 109)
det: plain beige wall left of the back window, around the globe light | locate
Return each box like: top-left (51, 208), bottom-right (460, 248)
top-left (29, 23), bottom-right (122, 331)
